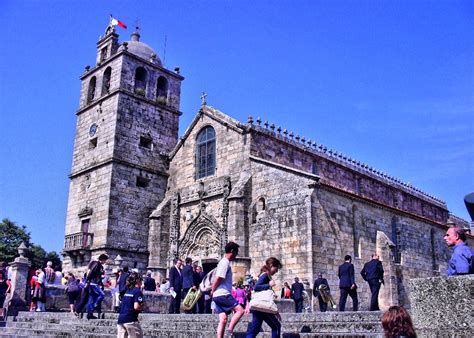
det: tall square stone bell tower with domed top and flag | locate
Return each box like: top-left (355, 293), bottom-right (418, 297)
top-left (63, 25), bottom-right (184, 272)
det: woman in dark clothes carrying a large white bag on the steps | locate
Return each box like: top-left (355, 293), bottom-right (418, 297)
top-left (246, 257), bottom-right (282, 338)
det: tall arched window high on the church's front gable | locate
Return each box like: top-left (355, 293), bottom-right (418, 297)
top-left (196, 126), bottom-right (216, 179)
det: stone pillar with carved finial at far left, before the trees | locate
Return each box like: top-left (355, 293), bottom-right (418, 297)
top-left (8, 242), bottom-right (31, 315)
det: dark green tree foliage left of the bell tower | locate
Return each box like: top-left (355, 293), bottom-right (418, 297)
top-left (0, 218), bottom-right (62, 270)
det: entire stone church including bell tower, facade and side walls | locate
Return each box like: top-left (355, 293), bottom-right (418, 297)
top-left (63, 26), bottom-right (467, 309)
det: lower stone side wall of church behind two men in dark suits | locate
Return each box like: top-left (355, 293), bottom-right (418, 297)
top-left (312, 185), bottom-right (449, 309)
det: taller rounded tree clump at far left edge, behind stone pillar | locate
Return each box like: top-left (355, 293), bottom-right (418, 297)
top-left (0, 218), bottom-right (30, 262)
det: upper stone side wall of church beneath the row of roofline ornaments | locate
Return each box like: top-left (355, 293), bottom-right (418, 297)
top-left (250, 126), bottom-right (448, 223)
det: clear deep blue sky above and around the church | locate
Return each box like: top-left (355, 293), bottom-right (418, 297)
top-left (0, 0), bottom-right (474, 251)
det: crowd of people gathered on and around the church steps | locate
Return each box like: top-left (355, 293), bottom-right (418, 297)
top-left (0, 227), bottom-right (474, 338)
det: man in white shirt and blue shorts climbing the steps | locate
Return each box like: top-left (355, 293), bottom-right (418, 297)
top-left (211, 242), bottom-right (244, 338)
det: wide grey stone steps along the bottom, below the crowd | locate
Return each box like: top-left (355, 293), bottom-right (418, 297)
top-left (0, 311), bottom-right (383, 338)
